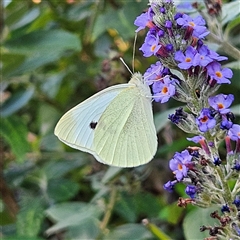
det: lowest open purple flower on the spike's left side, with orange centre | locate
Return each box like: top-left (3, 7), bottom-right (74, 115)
top-left (169, 150), bottom-right (192, 181)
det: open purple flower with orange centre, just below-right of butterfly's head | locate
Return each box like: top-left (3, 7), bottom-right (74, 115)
top-left (152, 76), bottom-right (175, 103)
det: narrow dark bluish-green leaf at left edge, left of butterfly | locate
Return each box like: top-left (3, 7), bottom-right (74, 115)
top-left (0, 87), bottom-right (34, 117)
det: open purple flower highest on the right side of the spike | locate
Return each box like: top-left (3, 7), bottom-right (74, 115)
top-left (177, 14), bottom-right (209, 38)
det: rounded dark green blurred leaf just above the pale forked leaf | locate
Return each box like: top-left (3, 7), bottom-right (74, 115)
top-left (47, 178), bottom-right (79, 202)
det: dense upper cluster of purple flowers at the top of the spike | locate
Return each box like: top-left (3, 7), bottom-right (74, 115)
top-left (134, 0), bottom-right (232, 108)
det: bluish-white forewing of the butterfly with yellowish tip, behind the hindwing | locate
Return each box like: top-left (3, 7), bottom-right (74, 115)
top-left (54, 84), bottom-right (131, 154)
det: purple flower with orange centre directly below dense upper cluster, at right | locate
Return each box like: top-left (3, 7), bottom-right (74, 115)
top-left (208, 93), bottom-right (234, 114)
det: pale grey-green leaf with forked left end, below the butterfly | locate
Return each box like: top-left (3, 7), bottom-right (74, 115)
top-left (46, 202), bottom-right (102, 234)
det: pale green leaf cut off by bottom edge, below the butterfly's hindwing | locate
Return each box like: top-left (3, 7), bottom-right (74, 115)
top-left (104, 223), bottom-right (153, 240)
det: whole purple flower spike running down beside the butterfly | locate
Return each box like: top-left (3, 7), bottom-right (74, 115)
top-left (134, 0), bottom-right (240, 236)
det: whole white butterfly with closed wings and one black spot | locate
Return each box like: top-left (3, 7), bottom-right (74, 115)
top-left (54, 73), bottom-right (157, 167)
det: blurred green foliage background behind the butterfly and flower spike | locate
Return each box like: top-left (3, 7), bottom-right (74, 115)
top-left (0, 0), bottom-right (240, 240)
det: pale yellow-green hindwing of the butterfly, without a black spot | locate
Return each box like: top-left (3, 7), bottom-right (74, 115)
top-left (94, 82), bottom-right (157, 167)
